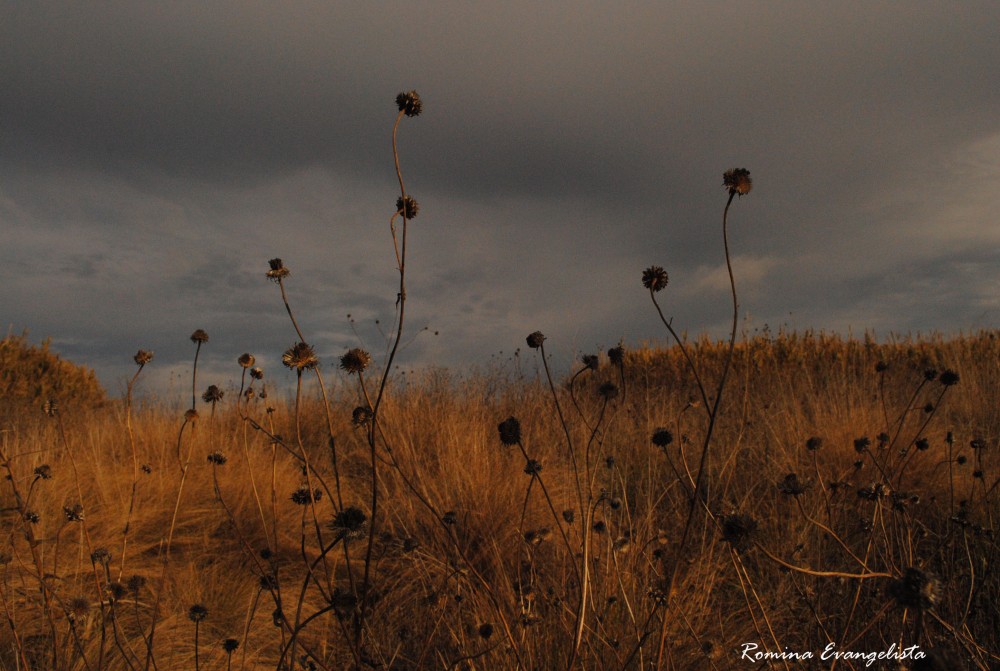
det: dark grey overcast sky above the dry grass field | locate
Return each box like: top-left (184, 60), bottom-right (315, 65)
top-left (0, 0), bottom-right (1000, 393)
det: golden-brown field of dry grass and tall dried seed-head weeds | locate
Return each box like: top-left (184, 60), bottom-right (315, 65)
top-left (0, 92), bottom-right (1000, 671)
